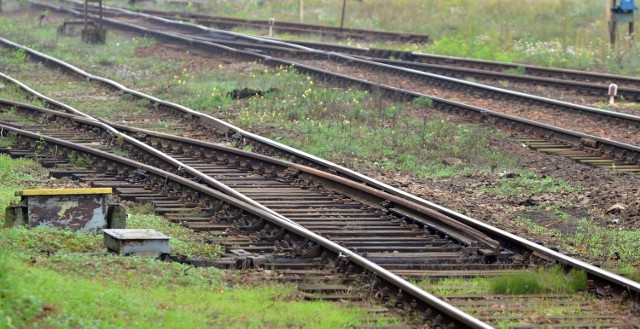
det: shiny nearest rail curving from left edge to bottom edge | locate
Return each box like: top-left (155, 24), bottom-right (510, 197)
top-left (0, 117), bottom-right (492, 328)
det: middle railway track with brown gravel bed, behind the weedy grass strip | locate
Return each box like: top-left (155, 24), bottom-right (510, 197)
top-left (25, 0), bottom-right (640, 179)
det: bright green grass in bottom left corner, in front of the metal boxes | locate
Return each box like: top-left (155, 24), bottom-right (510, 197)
top-left (0, 251), bottom-right (366, 328)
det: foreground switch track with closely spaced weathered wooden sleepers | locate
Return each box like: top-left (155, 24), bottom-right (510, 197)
top-left (1, 88), bottom-right (633, 327)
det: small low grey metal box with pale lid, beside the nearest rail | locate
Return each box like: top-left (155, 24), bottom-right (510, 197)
top-left (102, 229), bottom-right (169, 257)
